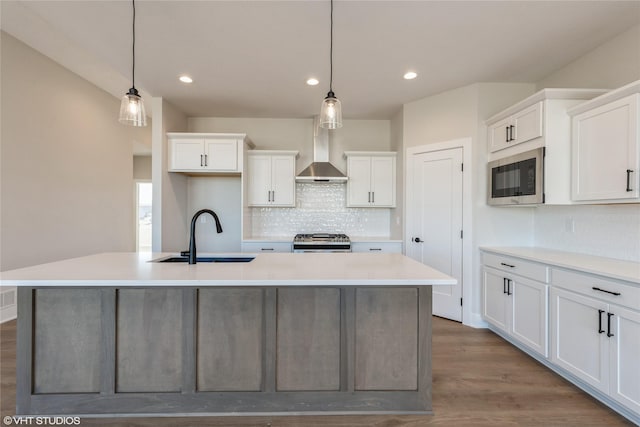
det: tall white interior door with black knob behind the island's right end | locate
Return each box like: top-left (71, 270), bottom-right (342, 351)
top-left (407, 148), bottom-right (462, 321)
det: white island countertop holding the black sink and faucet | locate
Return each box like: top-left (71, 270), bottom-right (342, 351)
top-left (0, 252), bottom-right (456, 287)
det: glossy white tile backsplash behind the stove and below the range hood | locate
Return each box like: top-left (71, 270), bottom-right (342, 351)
top-left (248, 183), bottom-right (391, 238)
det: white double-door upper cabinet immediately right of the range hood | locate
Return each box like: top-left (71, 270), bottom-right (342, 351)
top-left (345, 151), bottom-right (396, 208)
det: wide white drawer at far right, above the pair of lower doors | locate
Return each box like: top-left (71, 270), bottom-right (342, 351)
top-left (551, 268), bottom-right (640, 310)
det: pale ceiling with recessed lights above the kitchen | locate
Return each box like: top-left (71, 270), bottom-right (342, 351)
top-left (0, 0), bottom-right (640, 119)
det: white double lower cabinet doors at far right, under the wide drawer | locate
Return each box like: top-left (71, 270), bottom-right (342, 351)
top-left (551, 288), bottom-right (640, 414)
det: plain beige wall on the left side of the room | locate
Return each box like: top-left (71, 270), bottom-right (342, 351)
top-left (0, 32), bottom-right (151, 270)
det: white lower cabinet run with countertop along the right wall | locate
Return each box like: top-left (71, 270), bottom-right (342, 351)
top-left (482, 248), bottom-right (640, 425)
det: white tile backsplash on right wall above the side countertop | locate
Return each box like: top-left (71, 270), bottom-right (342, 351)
top-left (534, 204), bottom-right (640, 262)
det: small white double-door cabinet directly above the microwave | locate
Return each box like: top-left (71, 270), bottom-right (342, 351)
top-left (489, 102), bottom-right (544, 152)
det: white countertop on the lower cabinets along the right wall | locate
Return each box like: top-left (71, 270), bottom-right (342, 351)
top-left (480, 247), bottom-right (640, 284)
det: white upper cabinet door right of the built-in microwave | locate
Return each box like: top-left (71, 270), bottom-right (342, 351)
top-left (571, 95), bottom-right (640, 200)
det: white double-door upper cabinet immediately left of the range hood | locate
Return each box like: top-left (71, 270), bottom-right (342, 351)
top-left (247, 150), bottom-right (298, 207)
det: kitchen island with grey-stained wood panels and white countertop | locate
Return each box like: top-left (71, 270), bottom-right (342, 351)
top-left (2, 253), bottom-right (455, 416)
